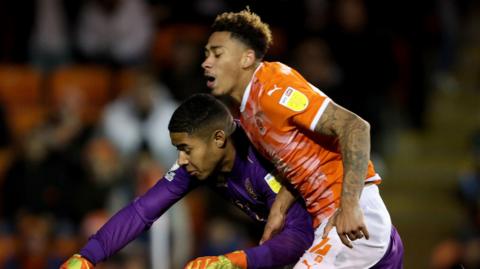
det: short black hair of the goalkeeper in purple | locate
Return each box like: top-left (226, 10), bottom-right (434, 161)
top-left (168, 93), bottom-right (235, 137)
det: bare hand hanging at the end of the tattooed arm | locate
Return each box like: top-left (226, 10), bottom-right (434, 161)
top-left (322, 205), bottom-right (370, 248)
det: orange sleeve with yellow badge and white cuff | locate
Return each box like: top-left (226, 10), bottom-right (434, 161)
top-left (261, 70), bottom-right (331, 131)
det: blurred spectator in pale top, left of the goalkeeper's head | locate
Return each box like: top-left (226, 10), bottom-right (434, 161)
top-left (101, 71), bottom-right (177, 165)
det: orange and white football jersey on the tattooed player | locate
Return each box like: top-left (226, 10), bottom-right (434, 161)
top-left (240, 62), bottom-right (380, 227)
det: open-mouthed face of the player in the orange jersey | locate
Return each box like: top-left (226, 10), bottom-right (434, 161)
top-left (202, 32), bottom-right (247, 95)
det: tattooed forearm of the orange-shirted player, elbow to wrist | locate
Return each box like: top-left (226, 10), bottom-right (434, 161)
top-left (339, 115), bottom-right (370, 208)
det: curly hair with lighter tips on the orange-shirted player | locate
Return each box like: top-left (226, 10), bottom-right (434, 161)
top-left (212, 7), bottom-right (273, 59)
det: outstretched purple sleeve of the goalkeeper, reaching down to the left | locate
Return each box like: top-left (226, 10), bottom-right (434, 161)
top-left (80, 163), bottom-right (196, 264)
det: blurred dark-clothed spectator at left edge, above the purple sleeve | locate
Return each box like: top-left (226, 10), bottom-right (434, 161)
top-left (2, 85), bottom-right (92, 222)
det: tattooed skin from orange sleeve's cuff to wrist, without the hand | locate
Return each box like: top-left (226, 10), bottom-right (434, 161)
top-left (315, 102), bottom-right (370, 204)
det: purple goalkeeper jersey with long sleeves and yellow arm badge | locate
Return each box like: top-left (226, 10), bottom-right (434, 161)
top-left (80, 130), bottom-right (314, 268)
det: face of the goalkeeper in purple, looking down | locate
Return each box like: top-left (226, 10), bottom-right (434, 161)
top-left (170, 132), bottom-right (224, 180)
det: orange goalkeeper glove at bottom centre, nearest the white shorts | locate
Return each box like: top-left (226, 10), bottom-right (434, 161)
top-left (185, 250), bottom-right (247, 269)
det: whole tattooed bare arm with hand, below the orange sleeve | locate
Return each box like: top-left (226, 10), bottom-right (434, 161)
top-left (315, 102), bottom-right (370, 248)
